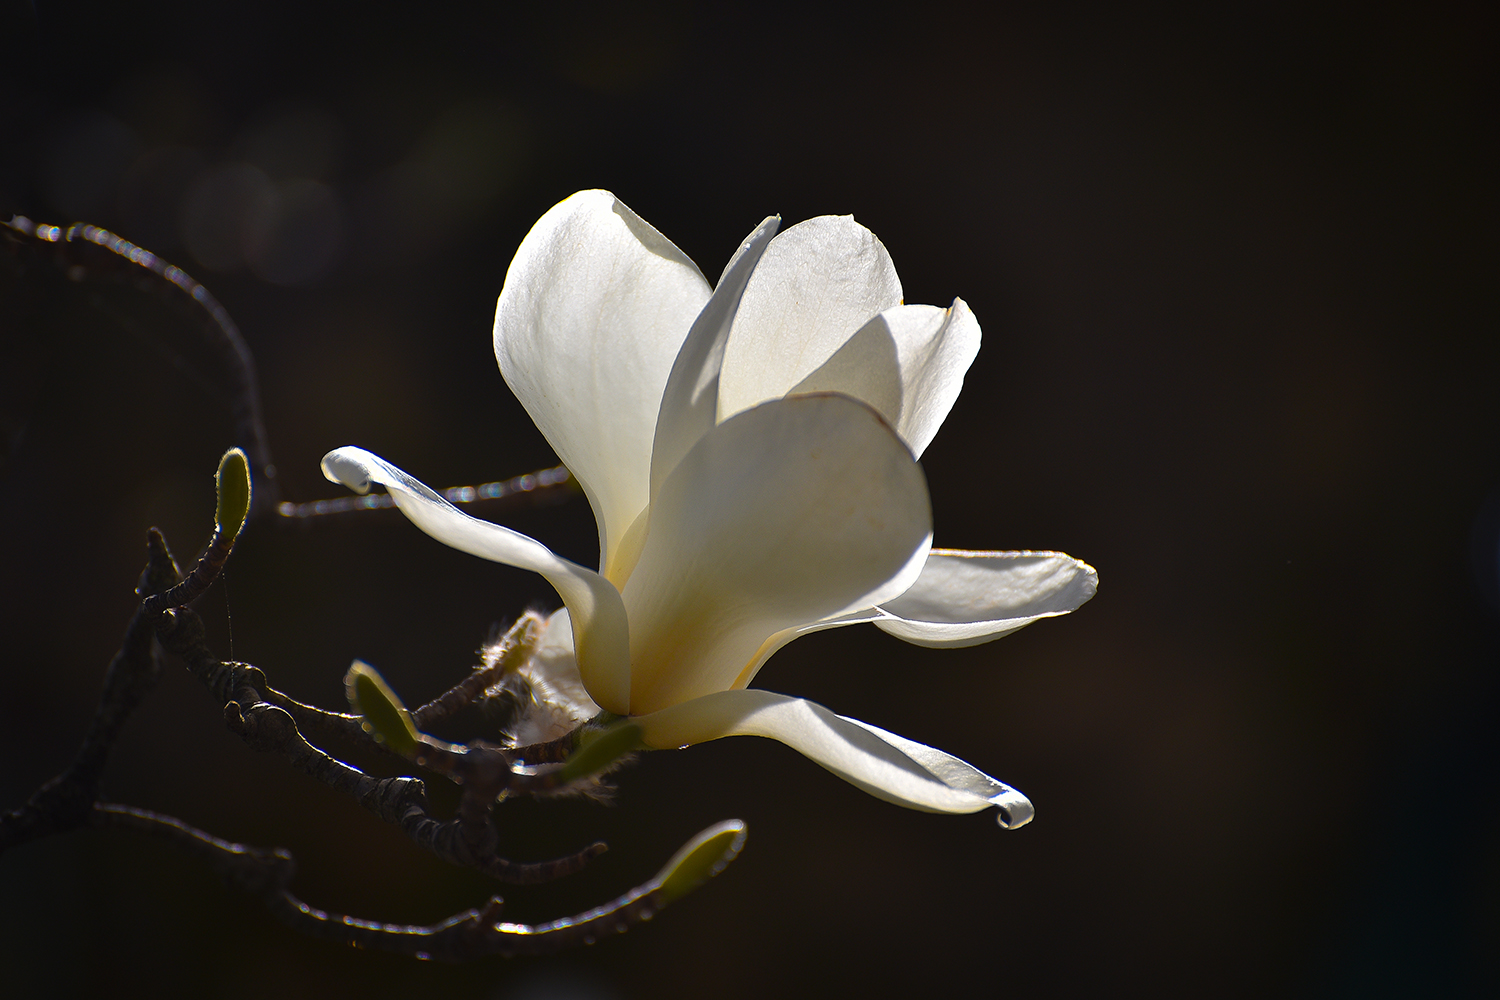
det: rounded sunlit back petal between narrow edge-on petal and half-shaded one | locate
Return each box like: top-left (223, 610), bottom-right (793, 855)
top-left (719, 216), bottom-right (902, 420)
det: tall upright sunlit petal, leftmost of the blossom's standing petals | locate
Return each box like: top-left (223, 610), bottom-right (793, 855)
top-left (495, 190), bottom-right (710, 579)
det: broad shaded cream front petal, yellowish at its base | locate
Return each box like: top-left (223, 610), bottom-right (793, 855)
top-left (618, 394), bottom-right (932, 712)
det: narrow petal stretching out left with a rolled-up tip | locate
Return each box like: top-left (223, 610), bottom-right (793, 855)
top-left (323, 448), bottom-right (630, 715)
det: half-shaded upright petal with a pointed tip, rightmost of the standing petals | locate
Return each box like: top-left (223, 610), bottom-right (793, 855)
top-left (792, 298), bottom-right (980, 459)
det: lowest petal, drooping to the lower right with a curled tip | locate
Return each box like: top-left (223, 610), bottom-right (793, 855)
top-left (632, 691), bottom-right (1034, 828)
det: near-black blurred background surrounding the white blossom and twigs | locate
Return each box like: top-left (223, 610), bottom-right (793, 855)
top-left (0, 0), bottom-right (1500, 999)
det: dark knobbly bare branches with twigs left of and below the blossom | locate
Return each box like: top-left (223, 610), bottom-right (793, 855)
top-left (0, 216), bottom-right (744, 960)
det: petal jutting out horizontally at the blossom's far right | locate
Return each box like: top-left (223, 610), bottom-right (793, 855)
top-left (875, 549), bottom-right (1100, 646)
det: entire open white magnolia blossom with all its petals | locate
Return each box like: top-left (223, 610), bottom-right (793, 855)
top-left (323, 190), bottom-right (1097, 826)
